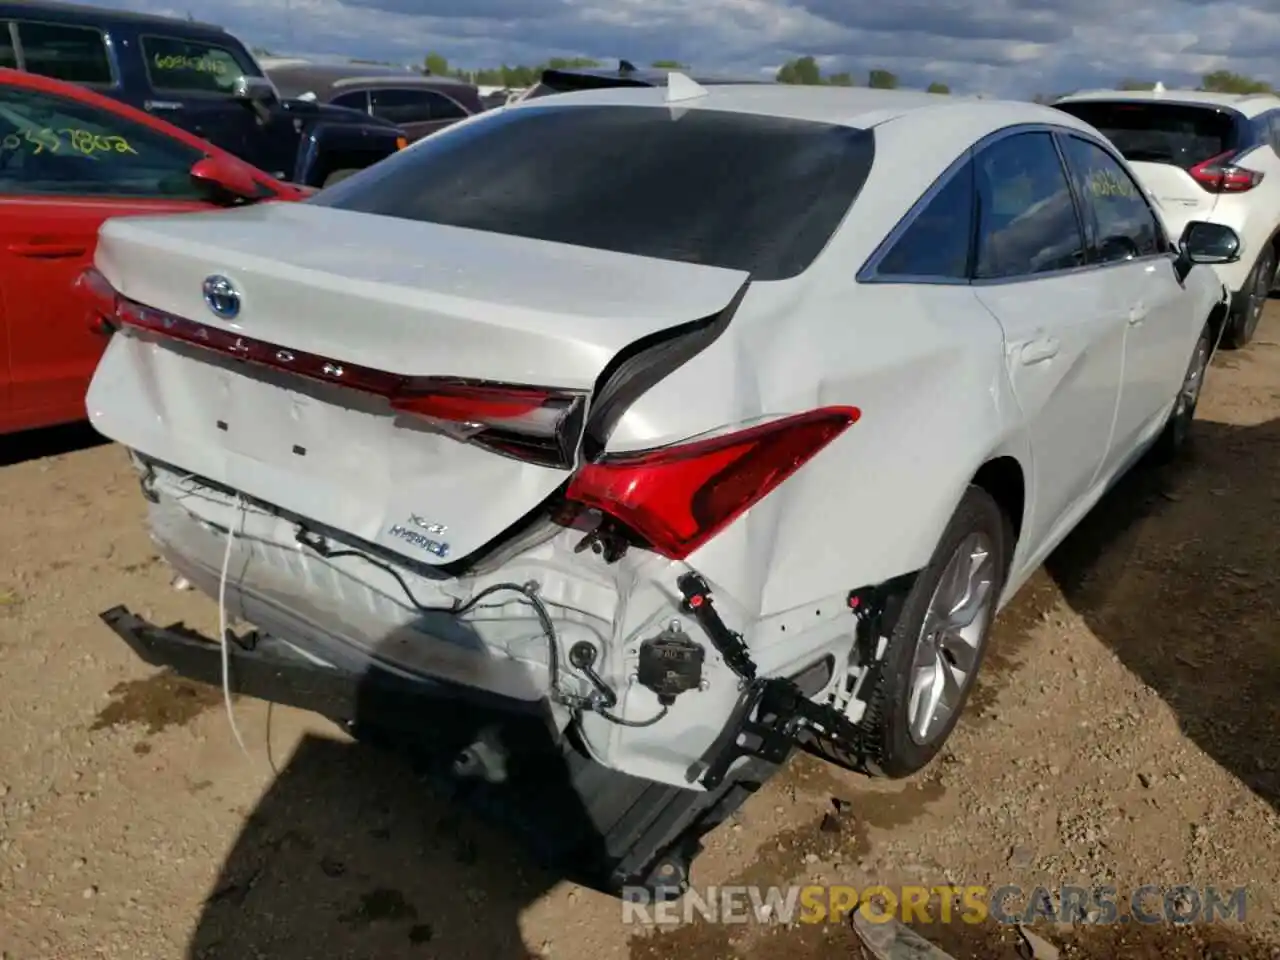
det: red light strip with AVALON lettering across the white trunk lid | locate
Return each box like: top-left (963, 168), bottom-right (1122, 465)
top-left (76, 269), bottom-right (586, 470)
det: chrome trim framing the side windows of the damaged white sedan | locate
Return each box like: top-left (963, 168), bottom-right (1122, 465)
top-left (854, 123), bottom-right (1175, 287)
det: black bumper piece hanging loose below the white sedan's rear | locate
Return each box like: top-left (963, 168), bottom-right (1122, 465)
top-left (100, 605), bottom-right (777, 896)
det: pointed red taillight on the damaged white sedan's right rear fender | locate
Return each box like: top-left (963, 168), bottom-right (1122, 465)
top-left (566, 407), bottom-right (860, 559)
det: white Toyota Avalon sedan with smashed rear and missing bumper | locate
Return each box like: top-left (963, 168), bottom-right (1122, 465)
top-left (82, 77), bottom-right (1239, 890)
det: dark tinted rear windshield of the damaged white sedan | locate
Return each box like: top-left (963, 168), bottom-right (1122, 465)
top-left (306, 105), bottom-right (874, 280)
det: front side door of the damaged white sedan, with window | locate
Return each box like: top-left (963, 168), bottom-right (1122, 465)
top-left (1059, 133), bottom-right (1207, 479)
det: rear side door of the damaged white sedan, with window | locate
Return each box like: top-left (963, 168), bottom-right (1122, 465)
top-left (973, 131), bottom-right (1125, 544)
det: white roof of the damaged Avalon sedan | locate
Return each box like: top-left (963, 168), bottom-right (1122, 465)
top-left (511, 83), bottom-right (1096, 142)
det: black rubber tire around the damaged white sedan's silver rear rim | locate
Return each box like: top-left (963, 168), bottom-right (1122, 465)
top-left (859, 486), bottom-right (1014, 780)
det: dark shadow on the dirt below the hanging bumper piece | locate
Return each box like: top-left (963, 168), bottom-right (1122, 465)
top-left (187, 736), bottom-right (556, 960)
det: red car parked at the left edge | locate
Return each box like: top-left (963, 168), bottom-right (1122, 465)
top-left (0, 69), bottom-right (311, 434)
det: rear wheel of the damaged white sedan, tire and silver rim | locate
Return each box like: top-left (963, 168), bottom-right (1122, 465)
top-left (839, 486), bottom-right (1014, 778)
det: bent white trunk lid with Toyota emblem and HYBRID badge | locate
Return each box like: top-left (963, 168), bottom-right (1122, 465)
top-left (88, 205), bottom-right (748, 566)
